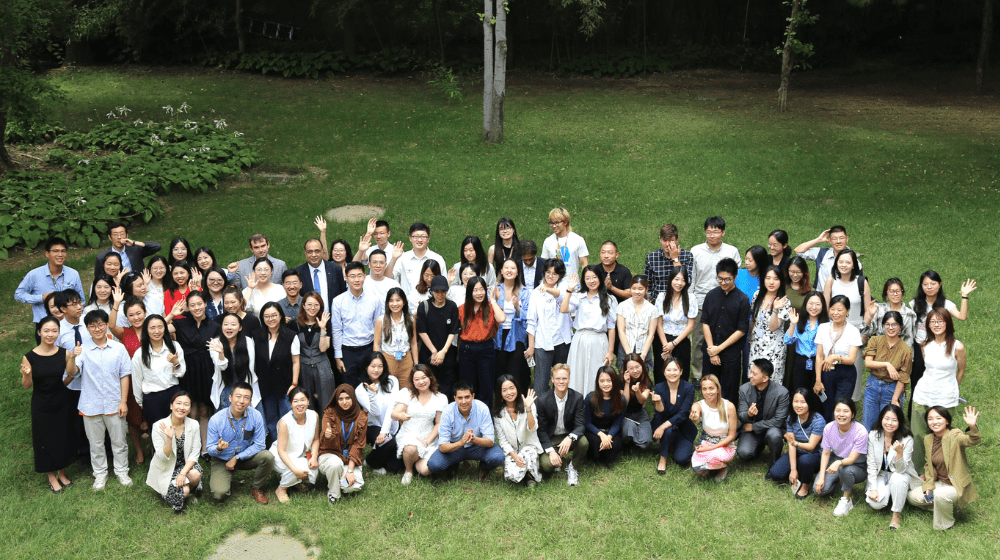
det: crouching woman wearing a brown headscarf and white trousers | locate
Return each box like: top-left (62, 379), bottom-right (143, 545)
top-left (319, 383), bottom-right (368, 504)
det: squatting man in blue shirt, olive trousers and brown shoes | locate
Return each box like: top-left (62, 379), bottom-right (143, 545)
top-left (208, 381), bottom-right (274, 504)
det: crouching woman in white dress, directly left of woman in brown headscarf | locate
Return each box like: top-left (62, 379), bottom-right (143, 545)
top-left (271, 387), bottom-right (319, 504)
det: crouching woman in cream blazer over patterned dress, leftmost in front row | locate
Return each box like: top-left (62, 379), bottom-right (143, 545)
top-left (146, 391), bottom-right (202, 513)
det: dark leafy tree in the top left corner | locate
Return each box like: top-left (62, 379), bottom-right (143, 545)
top-left (0, 0), bottom-right (65, 172)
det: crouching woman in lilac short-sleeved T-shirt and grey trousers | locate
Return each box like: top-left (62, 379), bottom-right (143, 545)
top-left (813, 395), bottom-right (868, 517)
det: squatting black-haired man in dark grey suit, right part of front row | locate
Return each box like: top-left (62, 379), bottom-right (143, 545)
top-left (736, 359), bottom-right (788, 466)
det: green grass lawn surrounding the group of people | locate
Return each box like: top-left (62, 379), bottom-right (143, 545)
top-left (0, 69), bottom-right (1000, 558)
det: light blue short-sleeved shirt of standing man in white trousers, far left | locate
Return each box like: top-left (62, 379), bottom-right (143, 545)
top-left (71, 331), bottom-right (132, 416)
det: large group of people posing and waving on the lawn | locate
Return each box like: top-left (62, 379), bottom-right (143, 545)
top-left (15, 208), bottom-right (980, 529)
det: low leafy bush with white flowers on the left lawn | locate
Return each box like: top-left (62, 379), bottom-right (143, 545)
top-left (0, 104), bottom-right (260, 259)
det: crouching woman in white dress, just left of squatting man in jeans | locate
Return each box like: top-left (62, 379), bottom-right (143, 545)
top-left (392, 364), bottom-right (448, 485)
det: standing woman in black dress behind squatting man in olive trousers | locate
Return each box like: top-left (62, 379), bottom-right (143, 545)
top-left (166, 290), bottom-right (222, 453)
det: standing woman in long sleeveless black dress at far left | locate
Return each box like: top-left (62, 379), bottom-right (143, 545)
top-left (21, 315), bottom-right (80, 494)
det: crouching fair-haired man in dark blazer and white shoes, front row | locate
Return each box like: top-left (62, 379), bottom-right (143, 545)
top-left (537, 364), bottom-right (588, 486)
